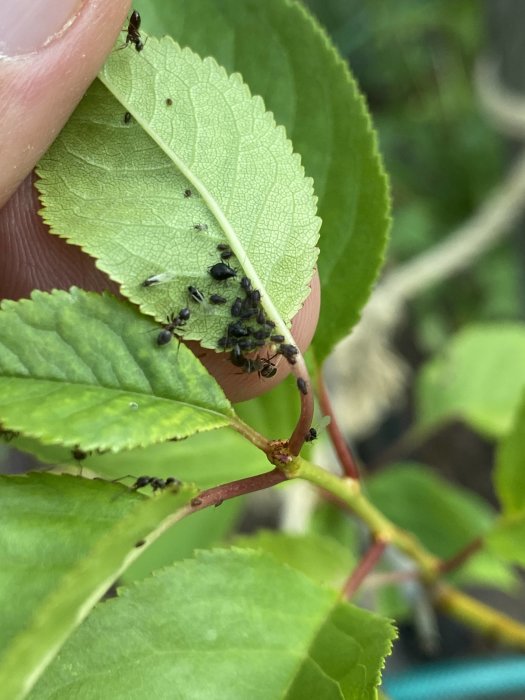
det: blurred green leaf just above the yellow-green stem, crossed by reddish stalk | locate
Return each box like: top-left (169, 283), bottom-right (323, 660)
top-left (367, 464), bottom-right (516, 589)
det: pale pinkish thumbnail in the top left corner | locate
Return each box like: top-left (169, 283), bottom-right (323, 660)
top-left (0, 0), bottom-right (84, 57)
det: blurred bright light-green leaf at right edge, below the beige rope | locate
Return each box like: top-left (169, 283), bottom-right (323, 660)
top-left (416, 323), bottom-right (525, 438)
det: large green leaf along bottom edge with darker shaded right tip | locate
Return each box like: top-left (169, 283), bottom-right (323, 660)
top-left (31, 550), bottom-right (394, 700)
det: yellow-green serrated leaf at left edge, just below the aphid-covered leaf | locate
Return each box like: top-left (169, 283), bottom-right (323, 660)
top-left (0, 289), bottom-right (233, 451)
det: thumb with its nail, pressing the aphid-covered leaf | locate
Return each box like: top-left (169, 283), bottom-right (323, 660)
top-left (0, 0), bottom-right (129, 207)
